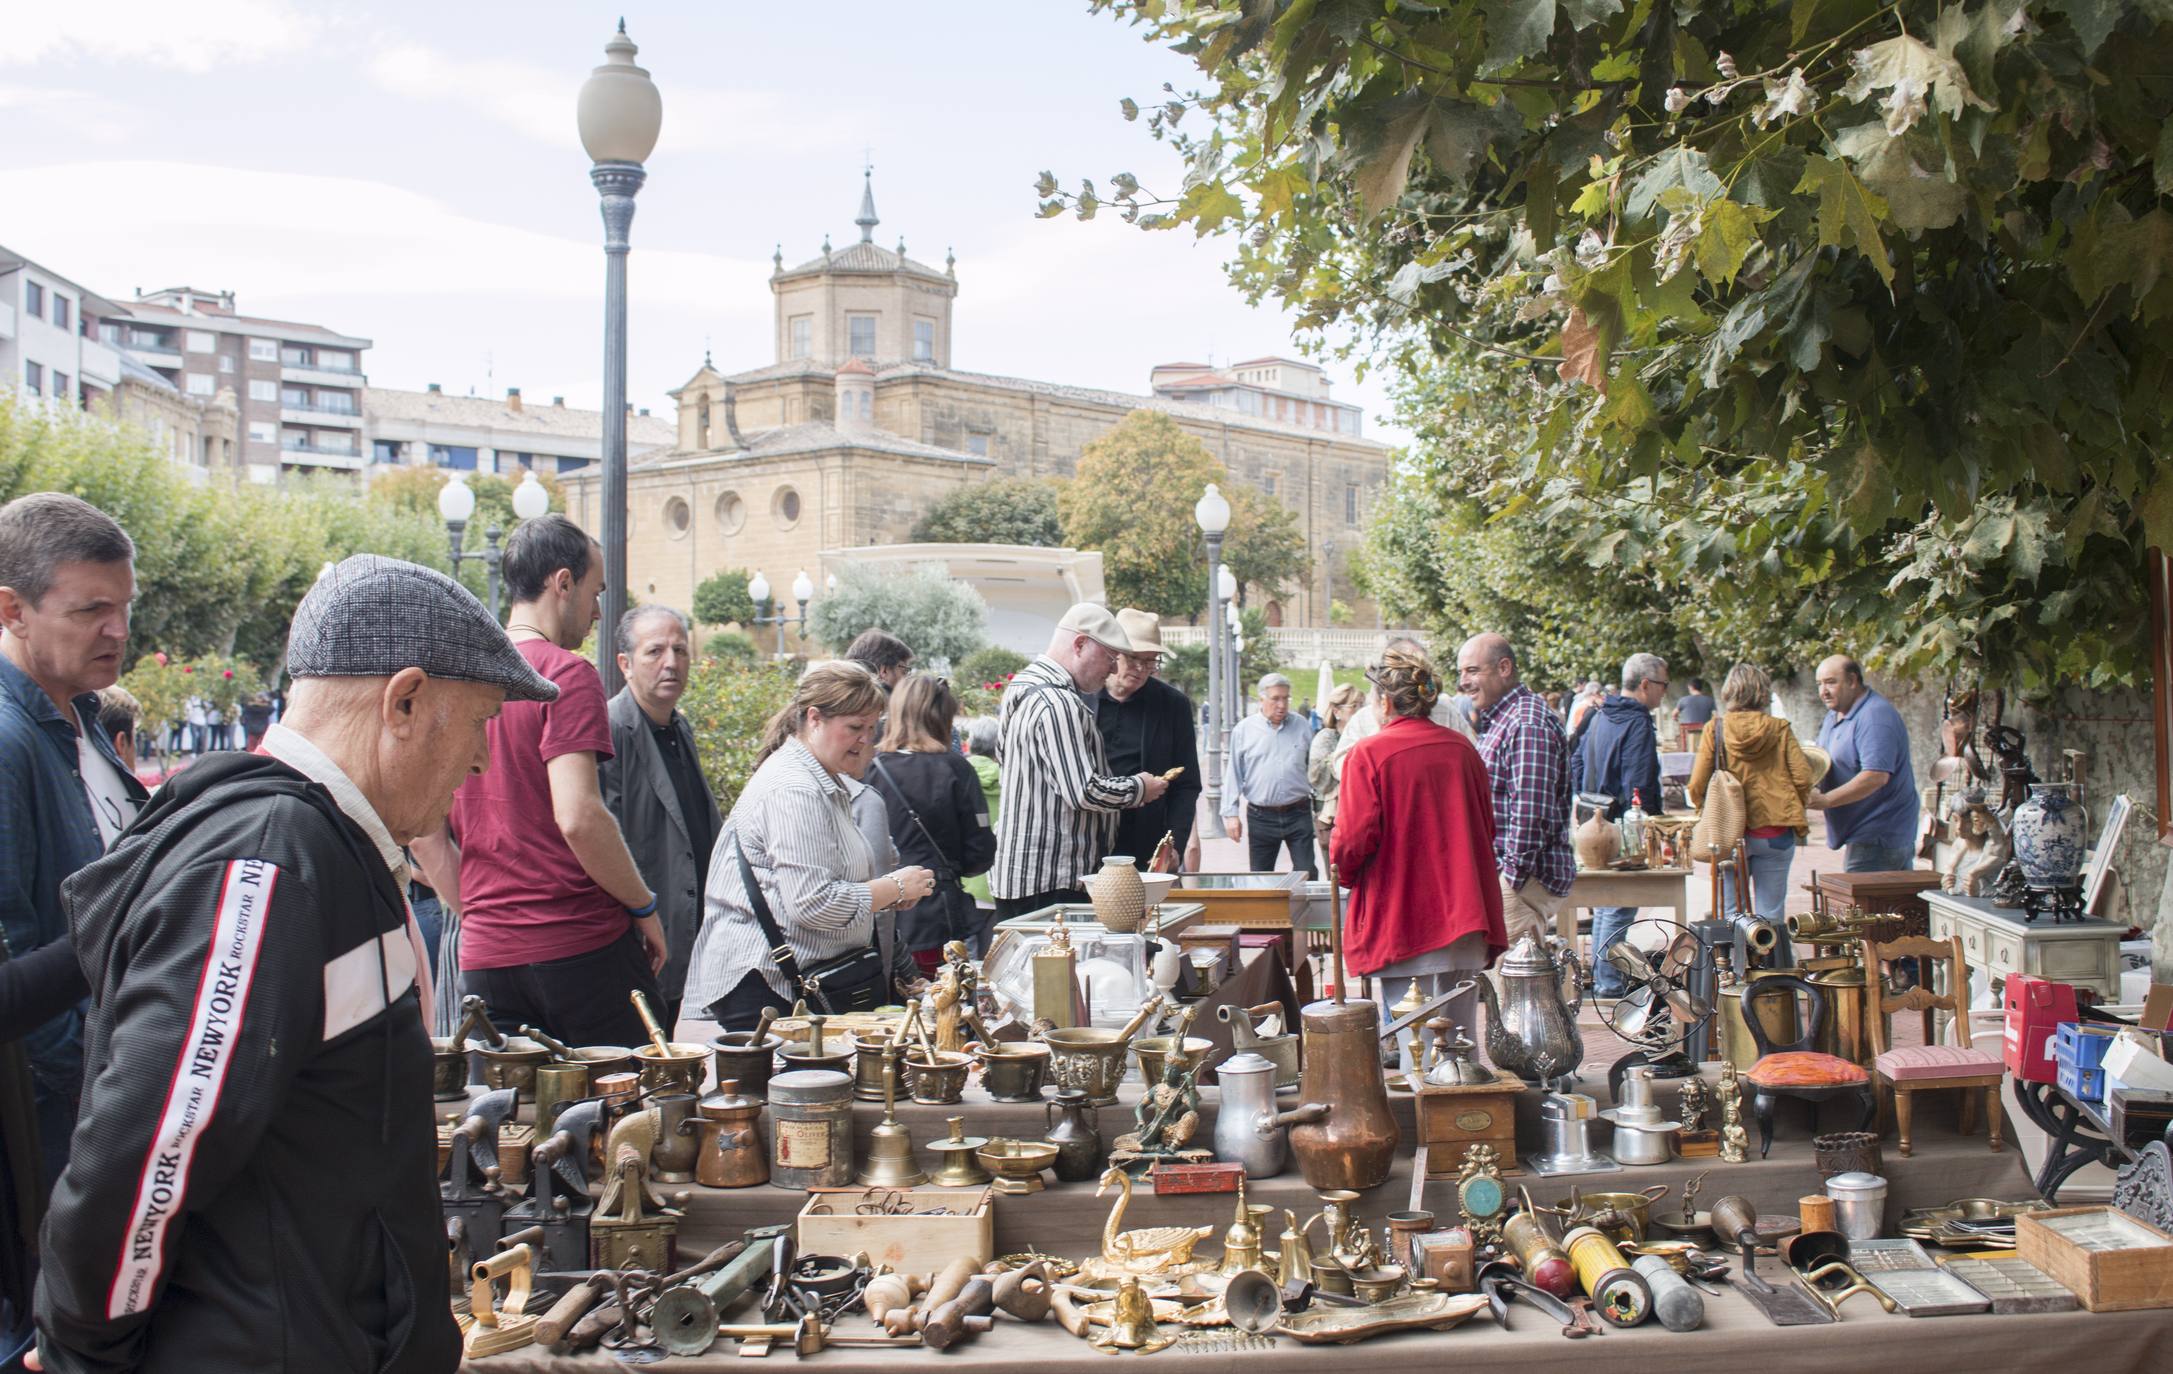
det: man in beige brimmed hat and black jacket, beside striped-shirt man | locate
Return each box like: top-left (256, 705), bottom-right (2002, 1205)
top-left (1093, 609), bottom-right (1199, 867)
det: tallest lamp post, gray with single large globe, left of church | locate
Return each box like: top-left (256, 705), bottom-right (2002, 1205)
top-left (576, 20), bottom-right (665, 698)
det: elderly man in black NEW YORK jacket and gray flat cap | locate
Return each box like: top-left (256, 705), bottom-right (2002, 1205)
top-left (37, 554), bottom-right (558, 1374)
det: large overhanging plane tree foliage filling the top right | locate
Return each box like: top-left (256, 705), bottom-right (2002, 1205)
top-left (1060, 0), bottom-right (2173, 685)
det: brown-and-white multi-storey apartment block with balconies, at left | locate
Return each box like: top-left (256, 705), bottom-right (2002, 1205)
top-left (104, 287), bottom-right (369, 483)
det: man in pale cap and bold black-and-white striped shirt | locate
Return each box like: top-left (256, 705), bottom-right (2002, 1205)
top-left (989, 602), bottom-right (1169, 920)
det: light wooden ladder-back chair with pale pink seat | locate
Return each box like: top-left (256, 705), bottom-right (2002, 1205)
top-left (1862, 935), bottom-right (2006, 1157)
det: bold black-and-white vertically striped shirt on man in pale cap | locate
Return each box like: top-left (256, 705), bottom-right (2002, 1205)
top-left (989, 654), bottom-right (1145, 898)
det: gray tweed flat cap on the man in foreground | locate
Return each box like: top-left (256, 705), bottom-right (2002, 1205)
top-left (287, 554), bottom-right (558, 702)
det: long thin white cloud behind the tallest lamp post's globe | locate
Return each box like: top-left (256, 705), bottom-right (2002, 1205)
top-left (369, 43), bottom-right (852, 154)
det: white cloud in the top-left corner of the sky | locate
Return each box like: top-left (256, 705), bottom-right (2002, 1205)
top-left (0, 0), bottom-right (324, 72)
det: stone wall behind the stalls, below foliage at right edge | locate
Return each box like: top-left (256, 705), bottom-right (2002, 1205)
top-left (1775, 672), bottom-right (2173, 980)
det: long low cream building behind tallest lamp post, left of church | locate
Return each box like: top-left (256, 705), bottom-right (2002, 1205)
top-left (363, 383), bottom-right (678, 476)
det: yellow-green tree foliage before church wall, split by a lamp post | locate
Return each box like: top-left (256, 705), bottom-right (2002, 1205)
top-left (1056, 411), bottom-right (1310, 620)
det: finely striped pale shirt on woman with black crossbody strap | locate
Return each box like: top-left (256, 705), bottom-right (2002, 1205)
top-left (687, 739), bottom-right (877, 1015)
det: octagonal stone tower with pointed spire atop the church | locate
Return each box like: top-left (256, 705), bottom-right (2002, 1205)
top-left (769, 167), bottom-right (958, 372)
